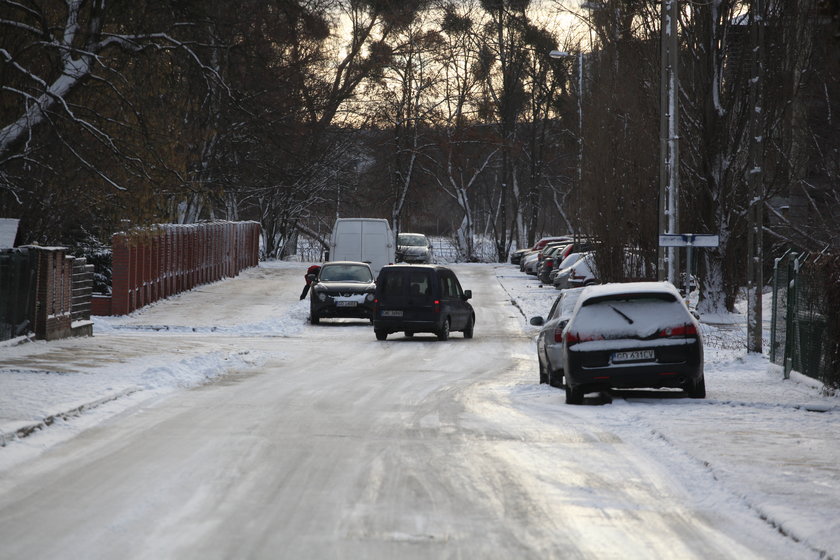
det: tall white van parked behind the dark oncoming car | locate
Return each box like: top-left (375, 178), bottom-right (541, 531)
top-left (329, 218), bottom-right (394, 278)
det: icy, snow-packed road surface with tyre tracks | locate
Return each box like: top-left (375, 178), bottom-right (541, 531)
top-left (0, 265), bottom-right (832, 560)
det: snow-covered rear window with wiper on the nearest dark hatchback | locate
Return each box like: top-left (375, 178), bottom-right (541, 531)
top-left (574, 293), bottom-right (692, 337)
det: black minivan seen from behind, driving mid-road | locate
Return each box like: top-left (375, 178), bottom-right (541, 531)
top-left (373, 265), bottom-right (475, 340)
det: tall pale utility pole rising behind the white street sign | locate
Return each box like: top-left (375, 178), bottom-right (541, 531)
top-left (657, 0), bottom-right (680, 284)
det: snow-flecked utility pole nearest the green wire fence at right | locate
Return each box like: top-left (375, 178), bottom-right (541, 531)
top-left (746, 0), bottom-right (765, 353)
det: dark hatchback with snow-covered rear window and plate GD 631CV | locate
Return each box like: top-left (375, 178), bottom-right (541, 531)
top-left (563, 282), bottom-right (706, 404)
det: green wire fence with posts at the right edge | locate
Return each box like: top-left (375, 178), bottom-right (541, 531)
top-left (770, 251), bottom-right (840, 389)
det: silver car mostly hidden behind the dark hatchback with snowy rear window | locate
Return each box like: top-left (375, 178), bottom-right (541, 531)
top-left (531, 288), bottom-right (583, 387)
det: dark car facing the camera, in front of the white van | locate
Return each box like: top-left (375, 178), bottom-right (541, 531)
top-left (309, 261), bottom-right (376, 325)
